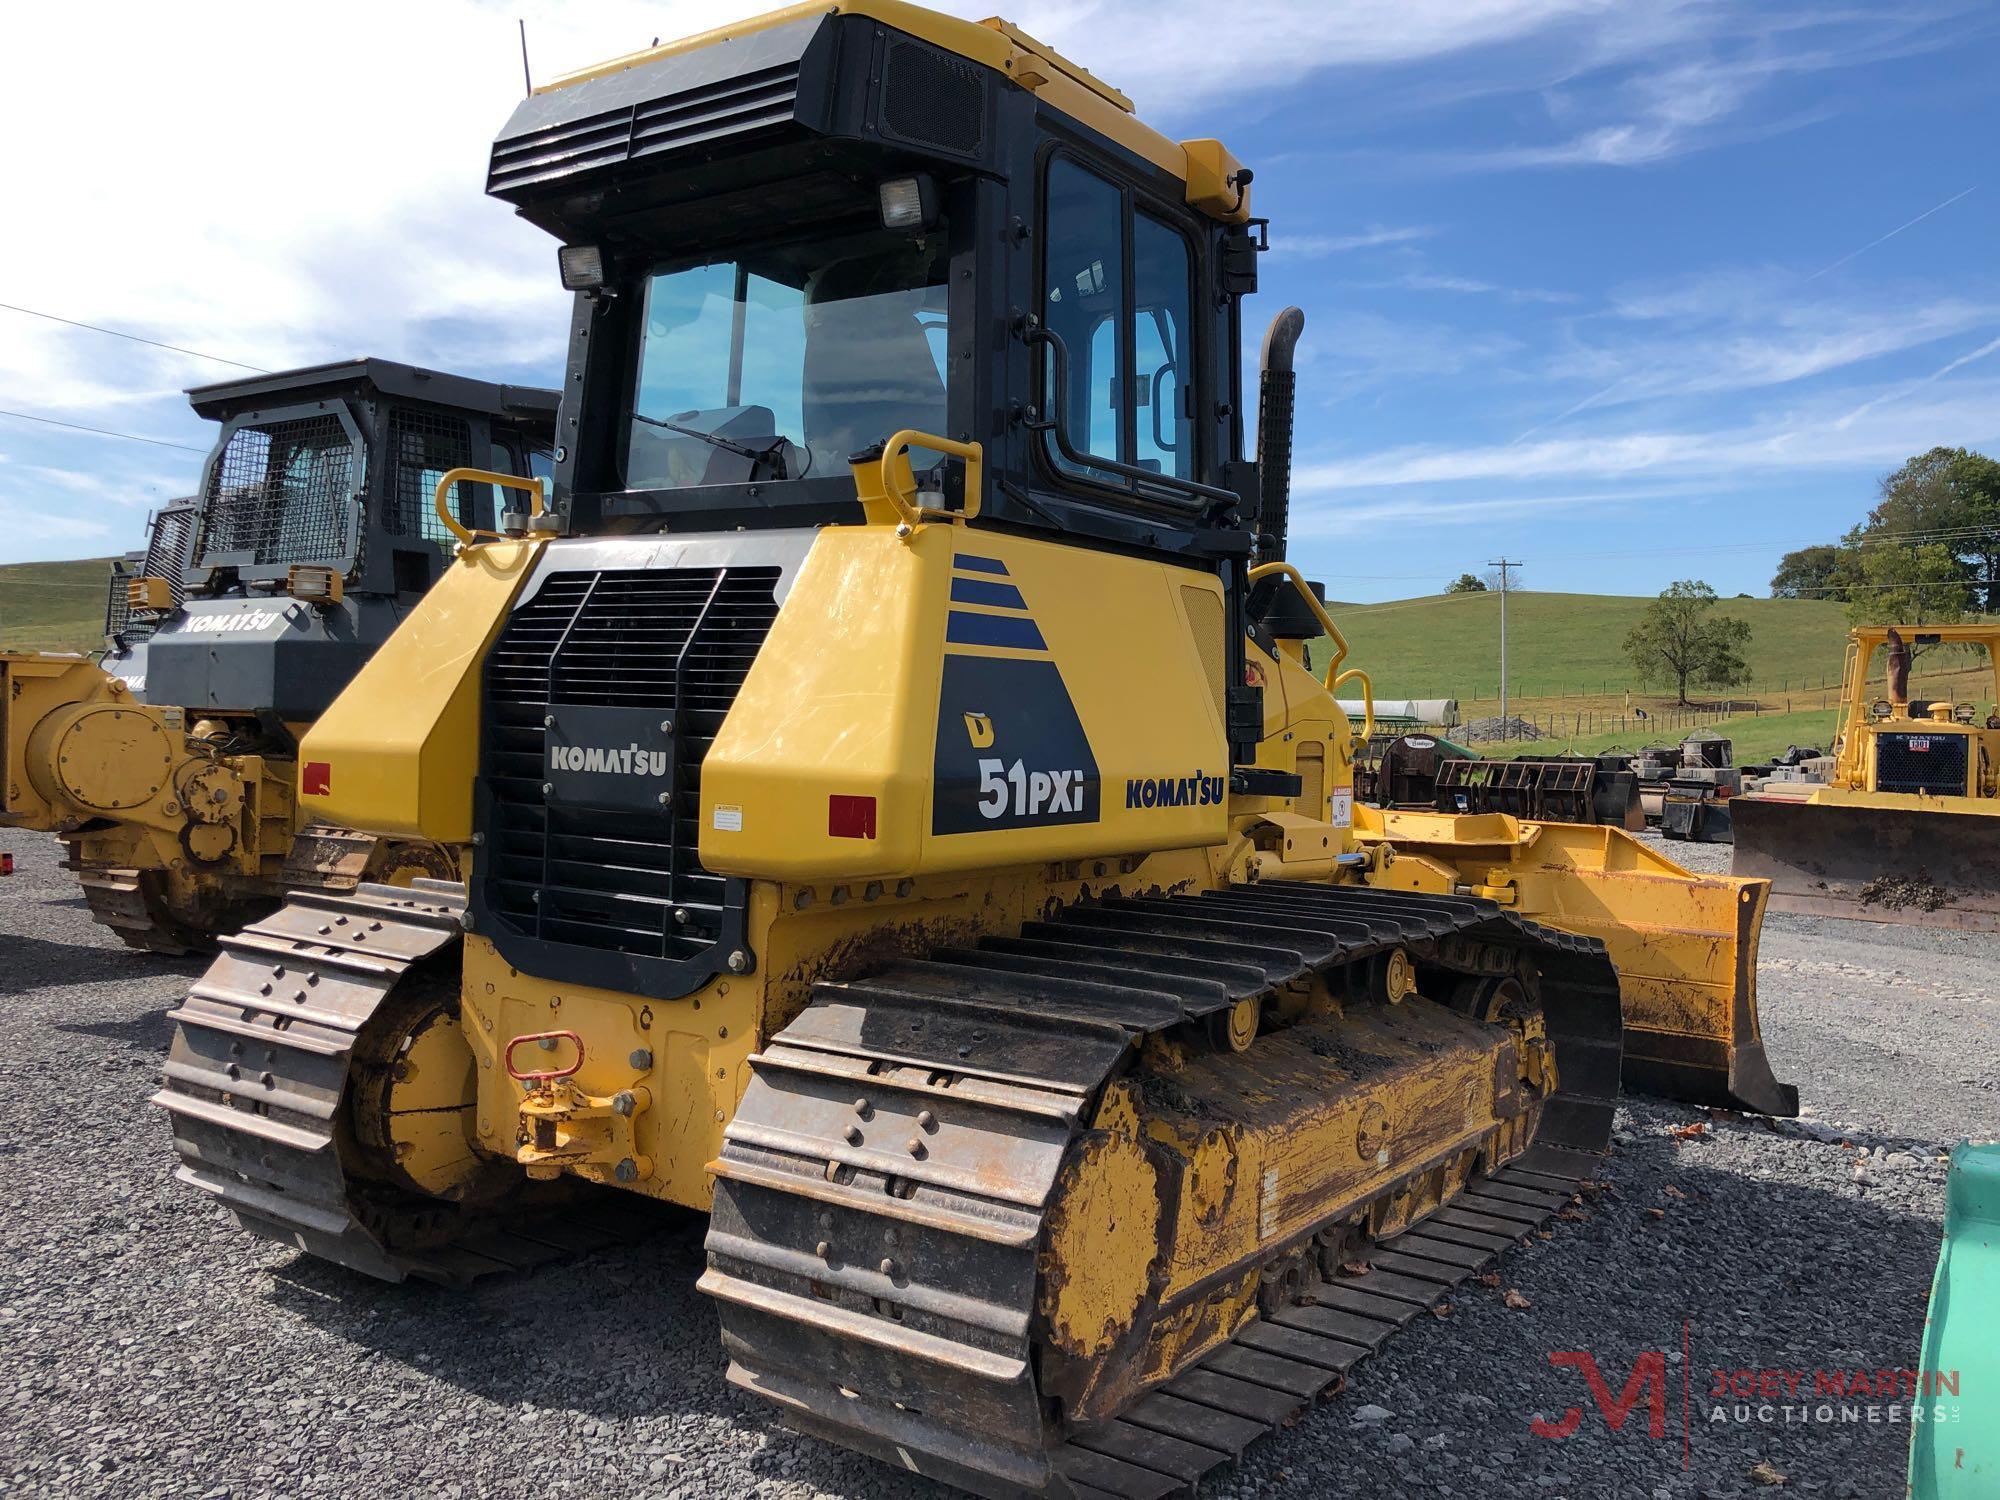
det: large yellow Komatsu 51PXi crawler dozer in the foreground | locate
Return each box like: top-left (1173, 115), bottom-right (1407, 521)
top-left (158, 0), bottom-right (1794, 1496)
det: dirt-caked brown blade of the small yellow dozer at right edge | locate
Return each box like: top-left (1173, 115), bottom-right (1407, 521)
top-left (1730, 796), bottom-right (2000, 932)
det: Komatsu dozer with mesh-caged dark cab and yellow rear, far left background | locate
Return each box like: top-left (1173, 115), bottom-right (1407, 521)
top-left (0, 360), bottom-right (556, 954)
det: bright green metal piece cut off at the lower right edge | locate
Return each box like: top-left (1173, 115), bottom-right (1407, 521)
top-left (1910, 1140), bottom-right (2000, 1500)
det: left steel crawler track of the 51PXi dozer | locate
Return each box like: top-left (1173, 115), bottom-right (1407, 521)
top-left (152, 882), bottom-right (642, 1284)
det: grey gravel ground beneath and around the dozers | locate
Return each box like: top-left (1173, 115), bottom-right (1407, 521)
top-left (0, 834), bottom-right (2000, 1500)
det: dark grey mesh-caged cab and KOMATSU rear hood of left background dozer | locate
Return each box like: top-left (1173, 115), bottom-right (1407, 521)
top-left (104, 360), bottom-right (556, 726)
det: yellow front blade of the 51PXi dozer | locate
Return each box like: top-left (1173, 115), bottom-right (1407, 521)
top-left (1356, 808), bottom-right (1798, 1116)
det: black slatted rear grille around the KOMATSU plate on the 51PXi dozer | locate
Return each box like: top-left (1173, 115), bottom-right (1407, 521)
top-left (482, 568), bottom-right (778, 976)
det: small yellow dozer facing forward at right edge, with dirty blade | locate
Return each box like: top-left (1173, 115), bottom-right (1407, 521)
top-left (1730, 624), bottom-right (2000, 932)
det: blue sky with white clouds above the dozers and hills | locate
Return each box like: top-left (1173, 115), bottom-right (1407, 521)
top-left (0, 0), bottom-right (2000, 600)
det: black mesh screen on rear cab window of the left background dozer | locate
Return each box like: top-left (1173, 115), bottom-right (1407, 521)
top-left (202, 414), bottom-right (360, 564)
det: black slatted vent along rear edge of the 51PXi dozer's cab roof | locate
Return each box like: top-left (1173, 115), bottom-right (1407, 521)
top-left (486, 62), bottom-right (798, 196)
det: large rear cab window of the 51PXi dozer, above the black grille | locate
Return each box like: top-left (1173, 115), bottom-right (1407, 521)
top-left (624, 230), bottom-right (946, 490)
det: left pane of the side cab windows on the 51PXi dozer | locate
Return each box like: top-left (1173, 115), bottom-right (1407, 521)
top-left (1042, 158), bottom-right (1128, 474)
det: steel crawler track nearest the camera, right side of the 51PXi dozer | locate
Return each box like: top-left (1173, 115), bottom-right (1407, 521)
top-left (702, 884), bottom-right (1622, 1500)
